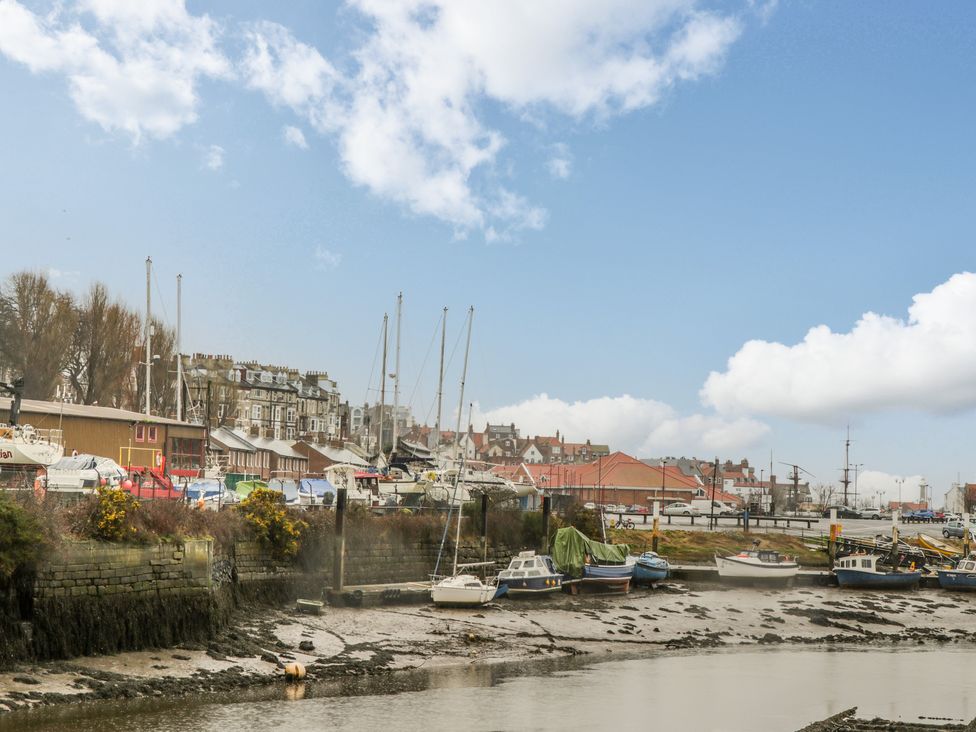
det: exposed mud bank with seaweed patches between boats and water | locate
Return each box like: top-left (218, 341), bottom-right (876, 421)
top-left (0, 583), bottom-right (976, 729)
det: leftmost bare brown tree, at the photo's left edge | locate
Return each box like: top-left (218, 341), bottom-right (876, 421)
top-left (0, 272), bottom-right (77, 399)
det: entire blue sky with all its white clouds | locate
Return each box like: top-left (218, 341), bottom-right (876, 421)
top-left (0, 0), bottom-right (976, 499)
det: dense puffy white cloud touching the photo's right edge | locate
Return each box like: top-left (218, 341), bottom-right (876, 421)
top-left (701, 272), bottom-right (976, 422)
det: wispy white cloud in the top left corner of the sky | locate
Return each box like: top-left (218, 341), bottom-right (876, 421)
top-left (0, 0), bottom-right (229, 143)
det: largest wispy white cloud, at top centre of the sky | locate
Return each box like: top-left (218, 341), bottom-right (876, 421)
top-left (242, 0), bottom-right (741, 234)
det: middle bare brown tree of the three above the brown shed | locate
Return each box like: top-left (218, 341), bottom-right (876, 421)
top-left (67, 282), bottom-right (141, 407)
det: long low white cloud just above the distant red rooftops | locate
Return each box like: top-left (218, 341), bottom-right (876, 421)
top-left (476, 394), bottom-right (769, 456)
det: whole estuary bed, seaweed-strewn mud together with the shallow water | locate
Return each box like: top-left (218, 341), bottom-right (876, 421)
top-left (0, 585), bottom-right (976, 732)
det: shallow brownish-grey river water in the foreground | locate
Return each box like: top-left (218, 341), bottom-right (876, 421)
top-left (0, 647), bottom-right (976, 732)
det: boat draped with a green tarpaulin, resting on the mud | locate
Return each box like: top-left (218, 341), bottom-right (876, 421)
top-left (552, 526), bottom-right (637, 592)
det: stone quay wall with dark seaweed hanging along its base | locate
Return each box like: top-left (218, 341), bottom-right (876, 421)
top-left (0, 539), bottom-right (512, 668)
